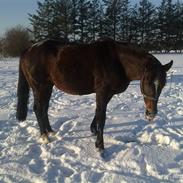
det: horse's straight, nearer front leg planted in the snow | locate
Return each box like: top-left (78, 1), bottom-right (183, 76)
top-left (93, 90), bottom-right (112, 151)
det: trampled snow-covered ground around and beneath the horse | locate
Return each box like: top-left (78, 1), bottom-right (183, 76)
top-left (0, 54), bottom-right (183, 183)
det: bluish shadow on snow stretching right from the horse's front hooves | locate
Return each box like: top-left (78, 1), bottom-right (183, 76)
top-left (101, 117), bottom-right (183, 161)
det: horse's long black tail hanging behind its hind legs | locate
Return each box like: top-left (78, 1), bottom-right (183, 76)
top-left (16, 52), bottom-right (30, 121)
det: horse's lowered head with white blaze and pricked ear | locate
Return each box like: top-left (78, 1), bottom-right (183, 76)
top-left (141, 61), bottom-right (173, 121)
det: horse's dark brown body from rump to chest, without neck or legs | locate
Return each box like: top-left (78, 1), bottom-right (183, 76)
top-left (21, 40), bottom-right (128, 95)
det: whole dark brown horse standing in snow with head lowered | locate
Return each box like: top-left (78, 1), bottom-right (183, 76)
top-left (17, 40), bottom-right (173, 150)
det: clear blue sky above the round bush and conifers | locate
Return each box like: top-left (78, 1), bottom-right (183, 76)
top-left (0, 0), bottom-right (183, 36)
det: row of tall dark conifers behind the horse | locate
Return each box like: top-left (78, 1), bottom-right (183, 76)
top-left (29, 0), bottom-right (183, 52)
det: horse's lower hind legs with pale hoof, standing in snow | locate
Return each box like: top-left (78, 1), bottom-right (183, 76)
top-left (33, 84), bottom-right (53, 143)
